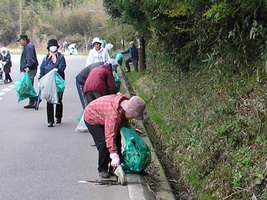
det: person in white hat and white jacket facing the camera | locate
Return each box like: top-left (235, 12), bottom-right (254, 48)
top-left (86, 37), bottom-right (109, 66)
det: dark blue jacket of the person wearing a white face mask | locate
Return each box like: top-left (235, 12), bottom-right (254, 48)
top-left (38, 52), bottom-right (66, 80)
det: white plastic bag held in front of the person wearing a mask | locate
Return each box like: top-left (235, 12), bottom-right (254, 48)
top-left (39, 70), bottom-right (58, 104)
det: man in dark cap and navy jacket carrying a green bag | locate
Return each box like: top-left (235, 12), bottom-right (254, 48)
top-left (17, 35), bottom-right (38, 108)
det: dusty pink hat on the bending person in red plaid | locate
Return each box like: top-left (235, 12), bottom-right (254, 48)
top-left (121, 96), bottom-right (146, 120)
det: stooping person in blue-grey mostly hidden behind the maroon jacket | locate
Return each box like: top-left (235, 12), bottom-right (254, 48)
top-left (75, 62), bottom-right (104, 109)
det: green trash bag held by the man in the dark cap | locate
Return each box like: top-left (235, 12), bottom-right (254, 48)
top-left (15, 72), bottom-right (37, 102)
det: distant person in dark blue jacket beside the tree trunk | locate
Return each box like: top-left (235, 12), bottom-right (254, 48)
top-left (121, 41), bottom-right (138, 73)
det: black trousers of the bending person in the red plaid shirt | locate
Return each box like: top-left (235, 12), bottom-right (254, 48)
top-left (85, 121), bottom-right (121, 172)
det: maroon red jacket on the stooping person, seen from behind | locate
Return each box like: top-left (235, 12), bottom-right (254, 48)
top-left (83, 65), bottom-right (116, 96)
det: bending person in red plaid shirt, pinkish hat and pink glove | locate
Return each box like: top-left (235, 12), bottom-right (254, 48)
top-left (84, 94), bottom-right (146, 178)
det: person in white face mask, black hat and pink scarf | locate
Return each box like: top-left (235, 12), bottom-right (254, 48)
top-left (38, 39), bottom-right (66, 127)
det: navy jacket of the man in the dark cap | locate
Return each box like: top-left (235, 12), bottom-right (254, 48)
top-left (20, 42), bottom-right (38, 72)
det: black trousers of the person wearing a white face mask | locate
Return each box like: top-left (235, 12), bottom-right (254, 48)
top-left (46, 94), bottom-right (63, 124)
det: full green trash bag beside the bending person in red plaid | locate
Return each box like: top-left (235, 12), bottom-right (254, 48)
top-left (121, 127), bottom-right (151, 172)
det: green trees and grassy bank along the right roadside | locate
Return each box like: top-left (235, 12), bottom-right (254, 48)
top-left (104, 0), bottom-right (267, 200)
